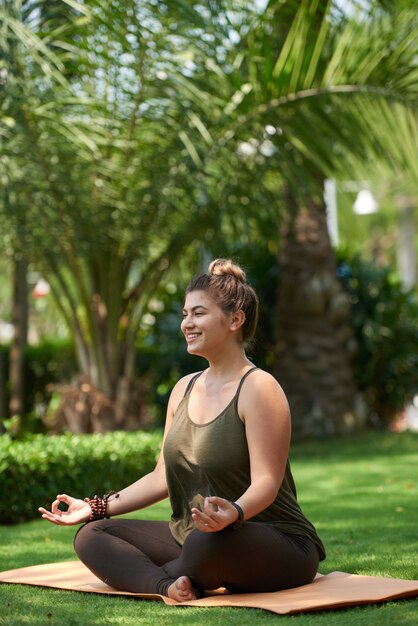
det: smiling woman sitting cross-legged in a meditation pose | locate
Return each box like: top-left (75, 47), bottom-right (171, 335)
top-left (39, 259), bottom-right (325, 602)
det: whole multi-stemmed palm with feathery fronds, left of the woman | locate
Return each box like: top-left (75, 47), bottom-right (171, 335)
top-left (0, 0), bottom-right (240, 431)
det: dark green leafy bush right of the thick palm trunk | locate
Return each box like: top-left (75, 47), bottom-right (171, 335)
top-left (338, 251), bottom-right (418, 425)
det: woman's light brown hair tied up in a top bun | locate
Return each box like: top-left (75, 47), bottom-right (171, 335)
top-left (186, 259), bottom-right (258, 341)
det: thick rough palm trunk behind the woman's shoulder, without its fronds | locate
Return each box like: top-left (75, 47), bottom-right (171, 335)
top-left (275, 197), bottom-right (359, 438)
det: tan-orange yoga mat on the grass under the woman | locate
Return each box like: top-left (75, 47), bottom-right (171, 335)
top-left (0, 561), bottom-right (418, 615)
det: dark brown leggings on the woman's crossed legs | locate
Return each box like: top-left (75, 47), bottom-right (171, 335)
top-left (74, 518), bottom-right (318, 595)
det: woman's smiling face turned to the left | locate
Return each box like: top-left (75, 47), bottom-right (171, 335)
top-left (181, 291), bottom-right (239, 358)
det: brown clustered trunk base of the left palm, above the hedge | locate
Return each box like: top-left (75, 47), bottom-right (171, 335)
top-left (44, 289), bottom-right (150, 433)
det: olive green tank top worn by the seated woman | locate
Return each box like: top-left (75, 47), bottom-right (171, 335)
top-left (164, 368), bottom-right (325, 560)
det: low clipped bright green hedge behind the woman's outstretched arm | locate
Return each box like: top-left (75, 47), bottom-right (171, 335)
top-left (0, 431), bottom-right (161, 524)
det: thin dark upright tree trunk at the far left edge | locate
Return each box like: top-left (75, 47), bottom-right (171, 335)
top-left (9, 258), bottom-right (29, 428)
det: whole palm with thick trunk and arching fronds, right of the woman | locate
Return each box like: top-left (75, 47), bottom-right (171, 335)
top-left (164, 0), bottom-right (417, 436)
